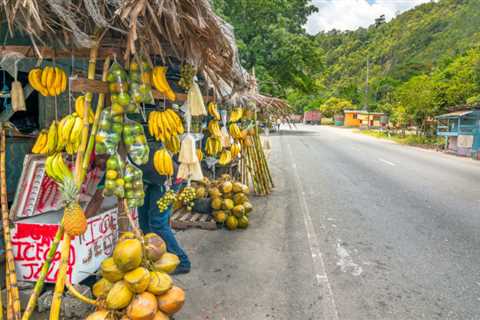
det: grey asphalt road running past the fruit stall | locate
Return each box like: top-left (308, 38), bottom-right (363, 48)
top-left (177, 126), bottom-right (480, 320)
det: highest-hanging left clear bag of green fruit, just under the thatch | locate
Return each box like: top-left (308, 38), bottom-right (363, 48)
top-left (107, 62), bottom-right (131, 116)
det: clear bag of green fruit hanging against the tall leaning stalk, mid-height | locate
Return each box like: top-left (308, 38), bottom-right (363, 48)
top-left (95, 109), bottom-right (123, 155)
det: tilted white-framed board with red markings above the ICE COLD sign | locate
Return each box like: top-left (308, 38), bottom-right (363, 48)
top-left (11, 154), bottom-right (103, 220)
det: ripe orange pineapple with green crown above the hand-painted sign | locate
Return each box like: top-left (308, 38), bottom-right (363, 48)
top-left (60, 178), bottom-right (87, 237)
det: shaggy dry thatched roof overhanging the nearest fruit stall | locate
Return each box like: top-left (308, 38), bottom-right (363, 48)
top-left (0, 0), bottom-right (245, 92)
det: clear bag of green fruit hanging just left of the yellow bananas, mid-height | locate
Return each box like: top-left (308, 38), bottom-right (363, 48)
top-left (123, 119), bottom-right (150, 166)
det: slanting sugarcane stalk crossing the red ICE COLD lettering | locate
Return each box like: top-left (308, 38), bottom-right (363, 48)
top-left (22, 221), bottom-right (64, 320)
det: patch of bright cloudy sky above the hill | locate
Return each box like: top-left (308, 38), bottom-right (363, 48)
top-left (305, 0), bottom-right (431, 34)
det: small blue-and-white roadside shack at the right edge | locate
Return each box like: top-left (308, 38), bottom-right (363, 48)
top-left (436, 109), bottom-right (480, 159)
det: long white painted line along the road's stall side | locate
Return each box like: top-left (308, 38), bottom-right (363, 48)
top-left (287, 144), bottom-right (339, 320)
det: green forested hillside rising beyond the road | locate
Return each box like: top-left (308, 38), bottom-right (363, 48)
top-left (316, 0), bottom-right (480, 108)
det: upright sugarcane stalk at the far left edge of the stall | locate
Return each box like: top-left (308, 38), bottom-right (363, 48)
top-left (0, 124), bottom-right (22, 320)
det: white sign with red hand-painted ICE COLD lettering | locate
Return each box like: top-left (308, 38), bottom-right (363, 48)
top-left (12, 208), bottom-right (118, 284)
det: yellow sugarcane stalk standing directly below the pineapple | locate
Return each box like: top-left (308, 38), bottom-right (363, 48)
top-left (50, 233), bottom-right (71, 320)
